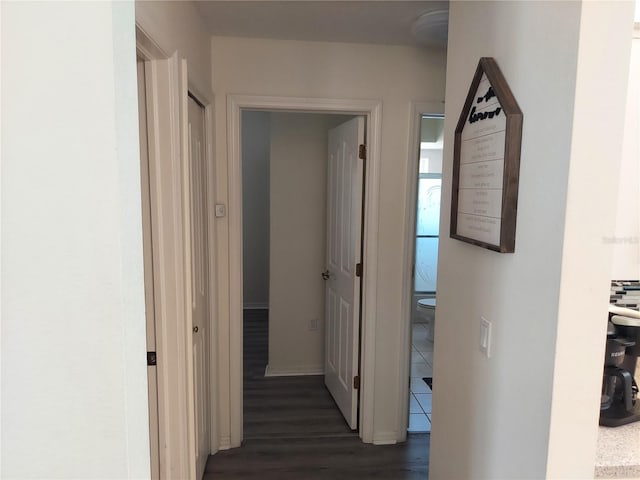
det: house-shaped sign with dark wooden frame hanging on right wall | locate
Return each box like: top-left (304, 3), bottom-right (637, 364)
top-left (449, 57), bottom-right (522, 253)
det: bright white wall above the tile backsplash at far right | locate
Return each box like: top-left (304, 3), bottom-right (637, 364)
top-left (606, 38), bottom-right (640, 280)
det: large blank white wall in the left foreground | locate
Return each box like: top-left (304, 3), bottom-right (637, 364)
top-left (0, 2), bottom-right (150, 479)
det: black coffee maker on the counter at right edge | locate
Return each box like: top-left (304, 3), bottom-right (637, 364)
top-left (600, 306), bottom-right (640, 427)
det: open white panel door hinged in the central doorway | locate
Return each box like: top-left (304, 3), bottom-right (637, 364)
top-left (323, 117), bottom-right (364, 430)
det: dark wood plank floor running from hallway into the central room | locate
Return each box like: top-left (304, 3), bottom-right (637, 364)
top-left (204, 310), bottom-right (429, 480)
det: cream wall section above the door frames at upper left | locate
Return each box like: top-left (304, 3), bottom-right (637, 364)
top-left (135, 0), bottom-right (211, 95)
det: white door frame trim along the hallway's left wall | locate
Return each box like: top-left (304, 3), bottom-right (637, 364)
top-left (136, 23), bottom-right (218, 479)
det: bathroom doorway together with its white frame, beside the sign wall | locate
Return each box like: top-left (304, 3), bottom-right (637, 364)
top-left (399, 102), bottom-right (444, 437)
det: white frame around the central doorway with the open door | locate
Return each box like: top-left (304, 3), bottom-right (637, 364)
top-left (225, 95), bottom-right (382, 448)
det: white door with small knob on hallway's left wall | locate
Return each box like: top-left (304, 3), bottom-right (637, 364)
top-left (189, 97), bottom-right (210, 478)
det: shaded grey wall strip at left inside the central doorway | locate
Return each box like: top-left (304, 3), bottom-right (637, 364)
top-left (242, 111), bottom-right (271, 308)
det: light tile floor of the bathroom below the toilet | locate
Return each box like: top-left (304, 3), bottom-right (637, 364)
top-left (408, 323), bottom-right (433, 433)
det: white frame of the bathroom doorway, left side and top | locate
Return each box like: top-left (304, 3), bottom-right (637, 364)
top-left (398, 102), bottom-right (444, 441)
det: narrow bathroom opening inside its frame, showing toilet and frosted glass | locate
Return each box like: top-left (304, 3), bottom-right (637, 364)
top-left (407, 114), bottom-right (444, 433)
